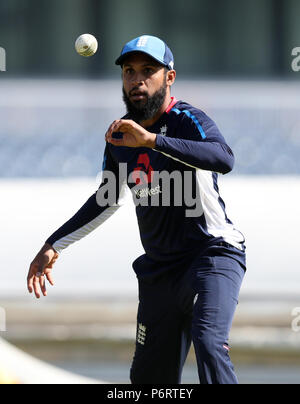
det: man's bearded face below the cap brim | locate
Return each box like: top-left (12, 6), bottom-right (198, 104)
top-left (122, 53), bottom-right (167, 121)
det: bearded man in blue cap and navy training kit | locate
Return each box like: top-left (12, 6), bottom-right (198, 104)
top-left (28, 36), bottom-right (246, 384)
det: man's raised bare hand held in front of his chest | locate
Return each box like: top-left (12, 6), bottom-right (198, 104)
top-left (105, 119), bottom-right (156, 149)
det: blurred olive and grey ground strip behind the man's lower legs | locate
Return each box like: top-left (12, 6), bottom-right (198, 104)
top-left (4, 339), bottom-right (300, 384)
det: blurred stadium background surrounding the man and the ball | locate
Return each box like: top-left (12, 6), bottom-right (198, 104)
top-left (0, 0), bottom-right (300, 384)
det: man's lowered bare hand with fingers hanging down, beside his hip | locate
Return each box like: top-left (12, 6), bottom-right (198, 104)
top-left (27, 244), bottom-right (59, 299)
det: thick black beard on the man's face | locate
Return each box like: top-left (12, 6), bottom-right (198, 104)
top-left (123, 80), bottom-right (167, 122)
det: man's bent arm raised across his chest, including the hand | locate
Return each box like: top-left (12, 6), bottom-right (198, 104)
top-left (106, 115), bottom-right (234, 174)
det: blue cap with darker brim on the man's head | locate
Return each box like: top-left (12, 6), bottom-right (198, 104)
top-left (116, 35), bottom-right (174, 70)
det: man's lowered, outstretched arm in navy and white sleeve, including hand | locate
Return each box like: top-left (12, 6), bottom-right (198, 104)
top-left (27, 145), bottom-right (125, 298)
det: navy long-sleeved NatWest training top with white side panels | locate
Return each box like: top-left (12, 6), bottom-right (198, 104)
top-left (47, 99), bottom-right (246, 276)
